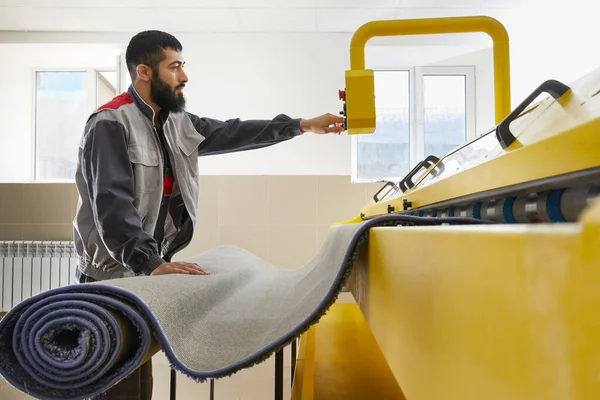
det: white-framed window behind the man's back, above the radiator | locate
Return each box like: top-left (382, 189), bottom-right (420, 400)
top-left (34, 70), bottom-right (117, 181)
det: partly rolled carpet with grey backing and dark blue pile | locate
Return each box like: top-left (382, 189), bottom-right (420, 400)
top-left (0, 215), bottom-right (482, 399)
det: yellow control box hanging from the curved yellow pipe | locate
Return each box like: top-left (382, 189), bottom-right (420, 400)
top-left (345, 70), bottom-right (375, 134)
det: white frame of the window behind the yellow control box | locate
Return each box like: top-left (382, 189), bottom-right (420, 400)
top-left (351, 65), bottom-right (477, 183)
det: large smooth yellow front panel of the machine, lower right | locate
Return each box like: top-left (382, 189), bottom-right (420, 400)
top-left (356, 202), bottom-right (600, 400)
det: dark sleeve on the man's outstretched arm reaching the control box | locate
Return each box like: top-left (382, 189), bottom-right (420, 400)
top-left (187, 113), bottom-right (302, 156)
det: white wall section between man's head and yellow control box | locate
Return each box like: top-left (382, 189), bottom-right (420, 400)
top-left (180, 34), bottom-right (350, 175)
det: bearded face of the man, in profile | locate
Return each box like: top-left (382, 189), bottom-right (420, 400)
top-left (150, 49), bottom-right (188, 112)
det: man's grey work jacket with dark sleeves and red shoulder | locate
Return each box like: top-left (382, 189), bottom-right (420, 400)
top-left (73, 86), bottom-right (302, 280)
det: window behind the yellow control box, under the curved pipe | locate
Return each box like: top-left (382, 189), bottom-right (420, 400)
top-left (352, 67), bottom-right (476, 182)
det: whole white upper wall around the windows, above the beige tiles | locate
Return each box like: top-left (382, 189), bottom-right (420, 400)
top-left (0, 33), bottom-right (492, 181)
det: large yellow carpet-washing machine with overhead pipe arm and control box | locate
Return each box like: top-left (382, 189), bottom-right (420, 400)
top-left (292, 17), bottom-right (600, 400)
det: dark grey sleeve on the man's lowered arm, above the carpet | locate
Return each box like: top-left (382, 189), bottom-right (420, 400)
top-left (80, 116), bottom-right (165, 275)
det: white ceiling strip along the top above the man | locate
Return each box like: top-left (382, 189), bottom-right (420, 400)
top-left (0, 0), bottom-right (535, 33)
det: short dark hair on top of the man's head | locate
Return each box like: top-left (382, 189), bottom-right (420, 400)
top-left (125, 31), bottom-right (183, 82)
